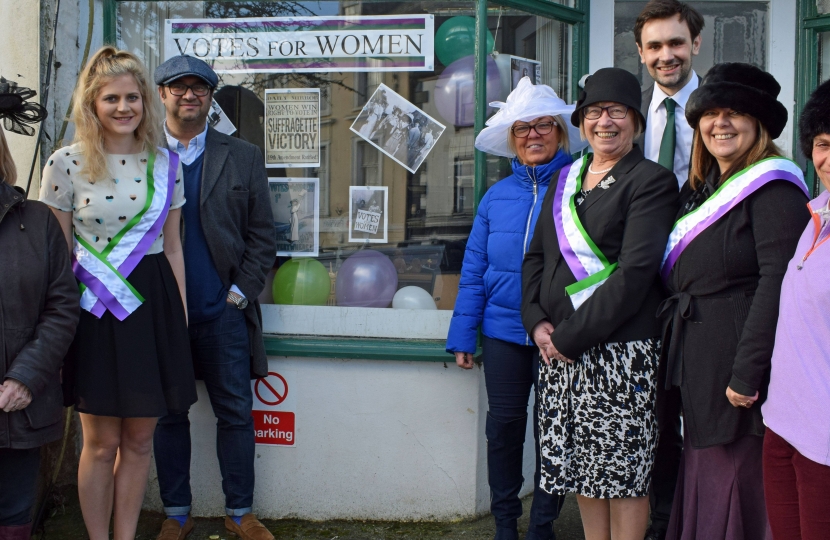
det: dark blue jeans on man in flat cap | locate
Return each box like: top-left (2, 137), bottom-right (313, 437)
top-left (153, 304), bottom-right (254, 516)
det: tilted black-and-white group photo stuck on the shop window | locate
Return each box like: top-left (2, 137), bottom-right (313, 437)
top-left (351, 84), bottom-right (444, 173)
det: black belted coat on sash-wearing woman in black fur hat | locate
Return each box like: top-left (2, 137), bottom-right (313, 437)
top-left (660, 174), bottom-right (810, 448)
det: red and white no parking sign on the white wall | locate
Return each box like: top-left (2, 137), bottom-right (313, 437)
top-left (251, 368), bottom-right (296, 446)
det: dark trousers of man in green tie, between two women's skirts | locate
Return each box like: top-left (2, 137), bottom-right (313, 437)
top-left (649, 359), bottom-right (683, 538)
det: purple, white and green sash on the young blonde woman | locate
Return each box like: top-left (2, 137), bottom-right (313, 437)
top-left (72, 148), bottom-right (179, 321)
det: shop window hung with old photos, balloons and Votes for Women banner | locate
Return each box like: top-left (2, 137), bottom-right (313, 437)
top-left (115, 0), bottom-right (574, 322)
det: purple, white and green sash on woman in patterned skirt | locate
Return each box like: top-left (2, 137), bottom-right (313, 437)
top-left (553, 154), bottom-right (617, 309)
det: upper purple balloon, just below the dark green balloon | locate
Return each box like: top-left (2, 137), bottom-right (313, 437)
top-left (435, 55), bottom-right (501, 126)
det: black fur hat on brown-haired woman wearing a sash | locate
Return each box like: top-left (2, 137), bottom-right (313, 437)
top-left (686, 62), bottom-right (787, 139)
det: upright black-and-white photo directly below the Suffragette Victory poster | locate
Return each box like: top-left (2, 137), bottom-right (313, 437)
top-left (268, 178), bottom-right (320, 257)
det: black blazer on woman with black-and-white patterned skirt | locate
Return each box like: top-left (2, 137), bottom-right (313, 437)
top-left (522, 145), bottom-right (677, 358)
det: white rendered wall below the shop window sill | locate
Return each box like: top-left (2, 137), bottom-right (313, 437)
top-left (145, 355), bottom-right (533, 521)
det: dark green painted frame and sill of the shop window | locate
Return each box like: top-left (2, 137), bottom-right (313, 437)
top-left (103, 0), bottom-right (590, 363)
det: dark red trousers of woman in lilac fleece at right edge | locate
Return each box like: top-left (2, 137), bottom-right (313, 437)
top-left (764, 428), bottom-right (830, 540)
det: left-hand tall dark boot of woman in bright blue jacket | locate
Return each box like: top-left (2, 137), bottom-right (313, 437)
top-left (485, 413), bottom-right (527, 540)
